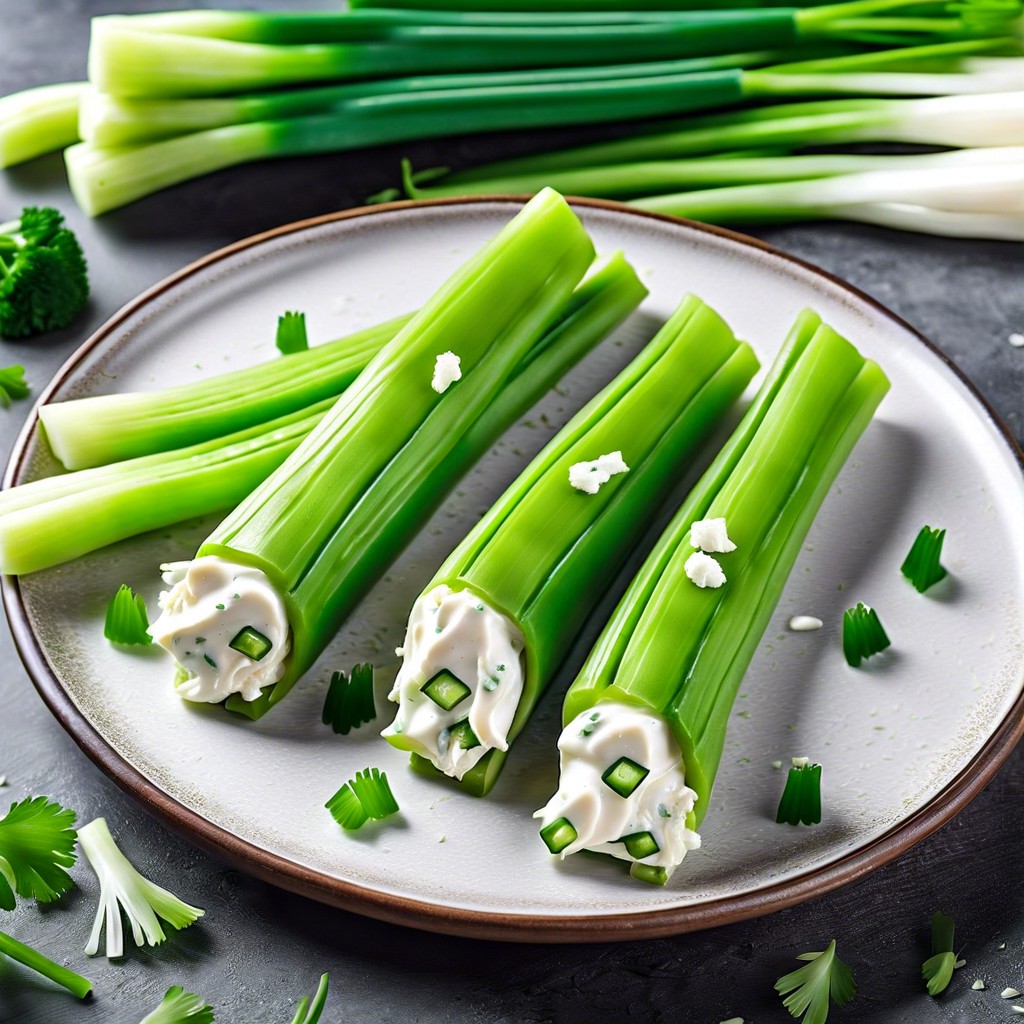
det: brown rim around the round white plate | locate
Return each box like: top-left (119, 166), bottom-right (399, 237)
top-left (0, 195), bottom-right (1024, 942)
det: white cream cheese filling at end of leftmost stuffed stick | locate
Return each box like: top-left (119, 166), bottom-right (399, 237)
top-left (150, 556), bottom-right (291, 703)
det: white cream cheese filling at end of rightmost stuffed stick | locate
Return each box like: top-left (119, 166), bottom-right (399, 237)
top-left (534, 700), bottom-right (700, 874)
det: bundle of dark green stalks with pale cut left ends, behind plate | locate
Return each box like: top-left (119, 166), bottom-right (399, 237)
top-left (0, 0), bottom-right (1019, 215)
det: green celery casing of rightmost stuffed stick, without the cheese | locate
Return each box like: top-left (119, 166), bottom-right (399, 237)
top-left (563, 311), bottom-right (889, 868)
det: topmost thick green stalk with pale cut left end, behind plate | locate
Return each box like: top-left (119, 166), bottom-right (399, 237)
top-left (89, 0), bottom-right (1020, 96)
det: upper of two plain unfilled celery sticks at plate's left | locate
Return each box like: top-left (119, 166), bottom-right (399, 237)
top-left (39, 314), bottom-right (411, 469)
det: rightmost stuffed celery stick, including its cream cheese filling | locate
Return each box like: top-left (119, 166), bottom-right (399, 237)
top-left (537, 312), bottom-right (889, 883)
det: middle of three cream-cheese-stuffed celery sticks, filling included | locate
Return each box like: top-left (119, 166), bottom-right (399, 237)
top-left (384, 296), bottom-right (757, 796)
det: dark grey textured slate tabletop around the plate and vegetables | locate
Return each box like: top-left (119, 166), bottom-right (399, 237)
top-left (0, 0), bottom-right (1024, 1024)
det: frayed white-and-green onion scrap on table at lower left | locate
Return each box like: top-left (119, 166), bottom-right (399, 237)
top-left (78, 818), bottom-right (204, 959)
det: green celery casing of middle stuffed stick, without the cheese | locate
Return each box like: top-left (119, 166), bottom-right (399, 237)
top-left (387, 296), bottom-right (757, 796)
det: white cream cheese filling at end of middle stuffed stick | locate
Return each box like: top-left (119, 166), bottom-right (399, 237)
top-left (381, 585), bottom-right (524, 779)
